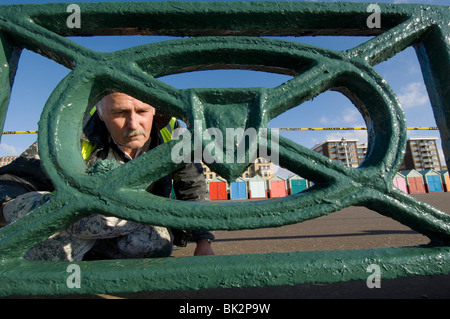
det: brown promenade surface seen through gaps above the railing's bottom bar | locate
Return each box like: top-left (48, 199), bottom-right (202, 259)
top-left (174, 193), bottom-right (436, 256)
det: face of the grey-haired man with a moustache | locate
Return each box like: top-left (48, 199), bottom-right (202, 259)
top-left (99, 93), bottom-right (154, 157)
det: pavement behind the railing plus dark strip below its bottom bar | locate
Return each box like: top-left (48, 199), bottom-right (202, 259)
top-left (3, 193), bottom-right (450, 299)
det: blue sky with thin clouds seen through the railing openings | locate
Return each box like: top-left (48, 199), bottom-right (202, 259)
top-left (0, 0), bottom-right (450, 176)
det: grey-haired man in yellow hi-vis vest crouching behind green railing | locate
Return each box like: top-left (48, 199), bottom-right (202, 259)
top-left (0, 92), bottom-right (214, 261)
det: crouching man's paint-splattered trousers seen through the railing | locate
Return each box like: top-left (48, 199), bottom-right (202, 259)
top-left (3, 192), bottom-right (173, 261)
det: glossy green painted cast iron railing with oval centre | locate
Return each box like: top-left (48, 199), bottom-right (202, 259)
top-left (0, 1), bottom-right (450, 295)
